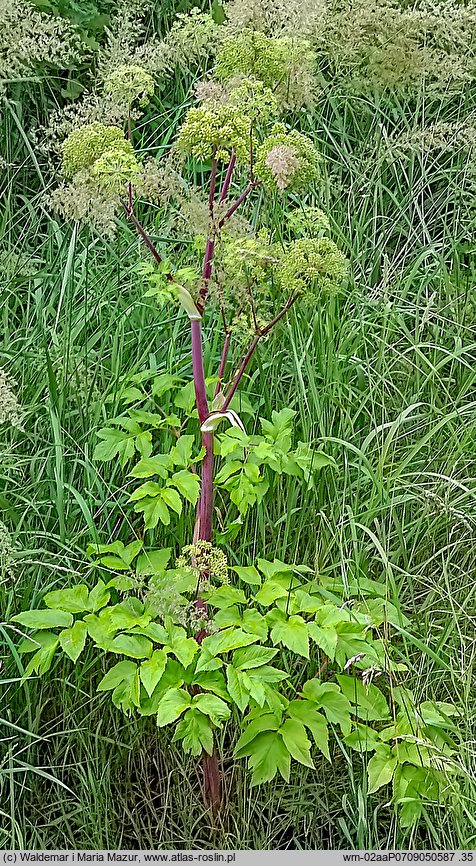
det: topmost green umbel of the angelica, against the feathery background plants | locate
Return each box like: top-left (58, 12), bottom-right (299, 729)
top-left (215, 28), bottom-right (289, 87)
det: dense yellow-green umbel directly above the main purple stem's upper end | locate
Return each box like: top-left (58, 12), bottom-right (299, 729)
top-left (177, 103), bottom-right (251, 161)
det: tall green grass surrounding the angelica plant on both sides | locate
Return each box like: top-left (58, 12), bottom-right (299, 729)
top-left (0, 15), bottom-right (476, 849)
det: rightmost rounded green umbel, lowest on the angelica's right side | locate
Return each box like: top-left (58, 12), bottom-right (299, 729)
top-left (279, 237), bottom-right (348, 300)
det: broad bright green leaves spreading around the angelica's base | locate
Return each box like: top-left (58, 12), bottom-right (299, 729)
top-left (10, 548), bottom-right (459, 826)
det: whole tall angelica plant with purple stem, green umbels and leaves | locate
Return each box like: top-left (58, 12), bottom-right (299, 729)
top-left (7, 13), bottom-right (466, 826)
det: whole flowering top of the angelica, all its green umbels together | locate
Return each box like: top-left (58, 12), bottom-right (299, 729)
top-left (54, 9), bottom-right (347, 320)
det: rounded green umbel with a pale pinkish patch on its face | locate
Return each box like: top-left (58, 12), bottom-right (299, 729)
top-left (255, 123), bottom-right (321, 192)
